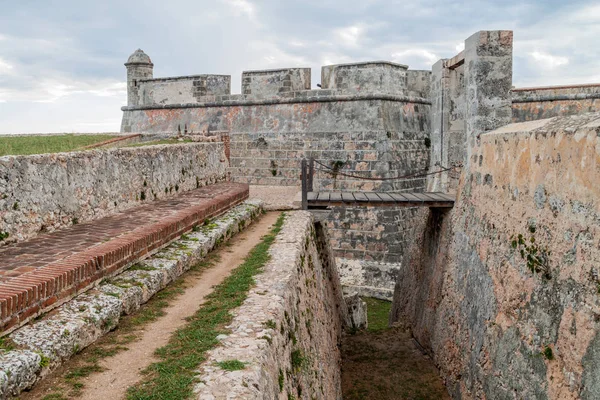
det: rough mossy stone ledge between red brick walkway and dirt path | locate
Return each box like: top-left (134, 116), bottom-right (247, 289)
top-left (0, 200), bottom-right (263, 398)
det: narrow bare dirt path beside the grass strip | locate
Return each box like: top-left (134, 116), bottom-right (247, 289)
top-left (22, 212), bottom-right (279, 400)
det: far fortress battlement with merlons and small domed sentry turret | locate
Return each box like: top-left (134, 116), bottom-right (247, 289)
top-left (123, 50), bottom-right (431, 111)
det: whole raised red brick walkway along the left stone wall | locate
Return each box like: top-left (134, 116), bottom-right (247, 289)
top-left (0, 183), bottom-right (248, 332)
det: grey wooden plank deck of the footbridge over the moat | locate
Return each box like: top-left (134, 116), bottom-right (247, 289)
top-left (307, 192), bottom-right (454, 209)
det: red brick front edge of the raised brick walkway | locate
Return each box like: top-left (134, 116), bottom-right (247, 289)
top-left (0, 183), bottom-right (249, 333)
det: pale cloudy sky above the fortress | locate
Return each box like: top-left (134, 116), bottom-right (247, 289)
top-left (0, 0), bottom-right (600, 133)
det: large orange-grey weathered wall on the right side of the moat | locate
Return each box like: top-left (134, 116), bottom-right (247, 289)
top-left (392, 113), bottom-right (600, 399)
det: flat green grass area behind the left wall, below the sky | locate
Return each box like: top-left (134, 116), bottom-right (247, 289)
top-left (0, 135), bottom-right (116, 156)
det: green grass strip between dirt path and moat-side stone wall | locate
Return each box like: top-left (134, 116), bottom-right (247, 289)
top-left (127, 213), bottom-right (285, 400)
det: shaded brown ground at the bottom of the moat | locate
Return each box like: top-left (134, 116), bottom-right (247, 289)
top-left (342, 328), bottom-right (450, 400)
